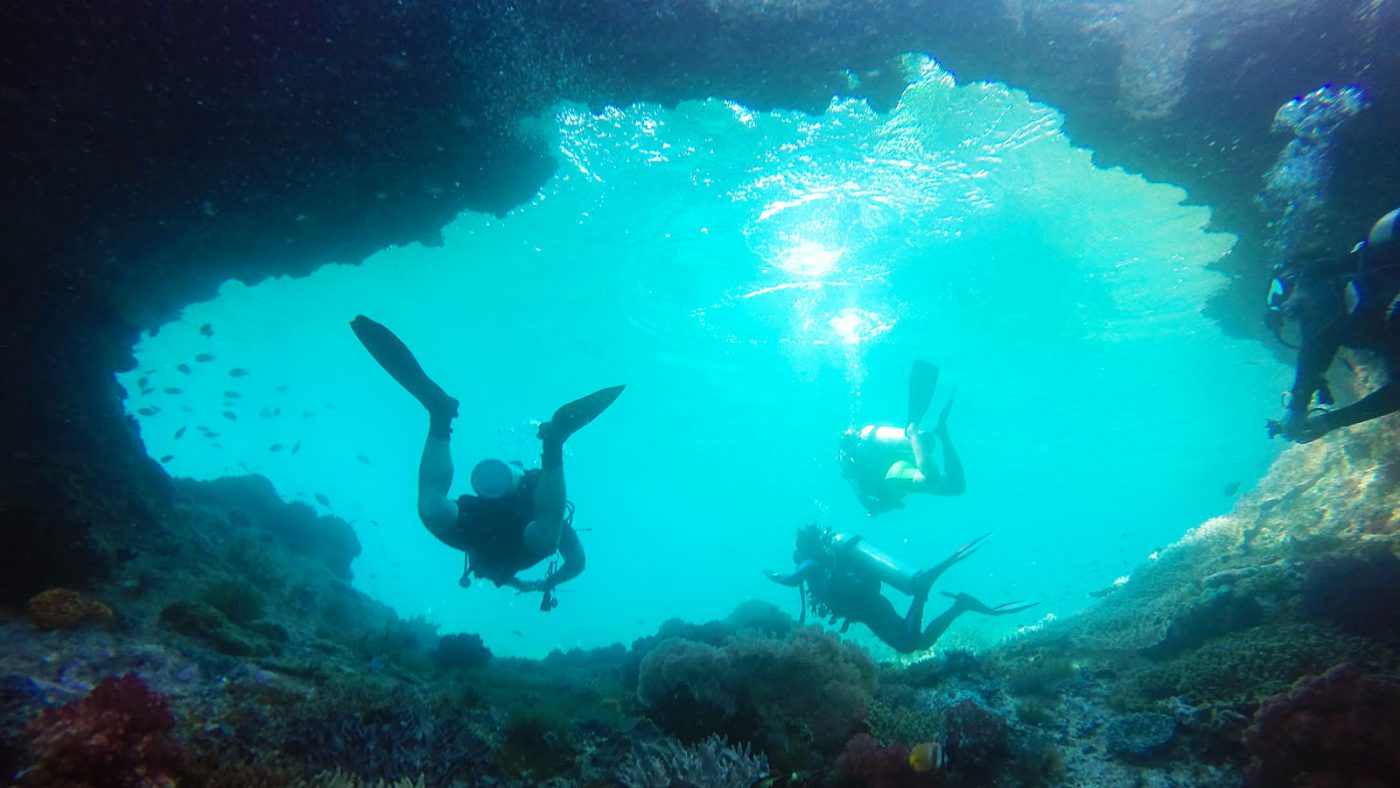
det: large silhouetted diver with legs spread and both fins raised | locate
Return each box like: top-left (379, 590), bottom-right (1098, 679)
top-left (350, 315), bottom-right (623, 612)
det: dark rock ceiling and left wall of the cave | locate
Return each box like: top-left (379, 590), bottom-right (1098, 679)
top-left (0, 0), bottom-right (1400, 571)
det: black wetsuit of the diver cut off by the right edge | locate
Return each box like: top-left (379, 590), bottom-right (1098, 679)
top-left (1289, 230), bottom-right (1400, 430)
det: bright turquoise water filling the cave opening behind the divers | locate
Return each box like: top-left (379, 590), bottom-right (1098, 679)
top-left (120, 63), bottom-right (1288, 655)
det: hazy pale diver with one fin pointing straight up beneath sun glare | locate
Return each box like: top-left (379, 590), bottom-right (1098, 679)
top-left (837, 361), bottom-right (967, 516)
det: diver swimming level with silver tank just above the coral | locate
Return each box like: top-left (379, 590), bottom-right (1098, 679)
top-left (763, 525), bottom-right (1039, 654)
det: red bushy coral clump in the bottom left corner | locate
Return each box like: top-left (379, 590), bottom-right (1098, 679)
top-left (24, 673), bottom-right (185, 788)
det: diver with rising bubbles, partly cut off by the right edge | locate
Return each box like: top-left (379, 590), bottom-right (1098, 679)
top-left (1266, 209), bottom-right (1400, 444)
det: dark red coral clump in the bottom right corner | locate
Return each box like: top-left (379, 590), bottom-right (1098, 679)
top-left (1245, 663), bottom-right (1400, 788)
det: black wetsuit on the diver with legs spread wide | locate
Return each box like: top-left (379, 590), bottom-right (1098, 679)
top-left (422, 470), bottom-right (584, 585)
